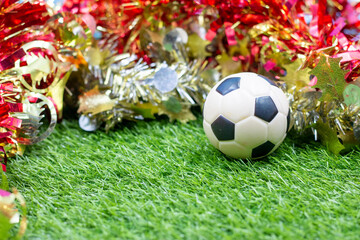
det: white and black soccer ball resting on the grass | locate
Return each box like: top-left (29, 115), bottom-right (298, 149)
top-left (203, 72), bottom-right (290, 159)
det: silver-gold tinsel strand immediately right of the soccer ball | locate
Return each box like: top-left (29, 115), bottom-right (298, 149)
top-left (287, 80), bottom-right (360, 154)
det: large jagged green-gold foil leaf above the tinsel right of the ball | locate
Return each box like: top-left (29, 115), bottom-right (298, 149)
top-left (310, 55), bottom-right (346, 101)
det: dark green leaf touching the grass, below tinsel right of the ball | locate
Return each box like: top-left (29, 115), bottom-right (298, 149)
top-left (315, 120), bottom-right (345, 155)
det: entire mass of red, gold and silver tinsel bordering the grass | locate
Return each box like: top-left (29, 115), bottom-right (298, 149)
top-left (0, 0), bottom-right (360, 235)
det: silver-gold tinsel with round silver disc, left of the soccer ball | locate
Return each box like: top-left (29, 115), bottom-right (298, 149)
top-left (69, 8), bottom-right (218, 131)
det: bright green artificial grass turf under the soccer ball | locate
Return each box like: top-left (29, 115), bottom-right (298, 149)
top-left (7, 116), bottom-right (360, 239)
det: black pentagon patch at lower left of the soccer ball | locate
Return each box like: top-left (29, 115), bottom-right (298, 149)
top-left (211, 115), bottom-right (235, 141)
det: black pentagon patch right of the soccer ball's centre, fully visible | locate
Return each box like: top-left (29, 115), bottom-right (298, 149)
top-left (255, 96), bottom-right (278, 122)
